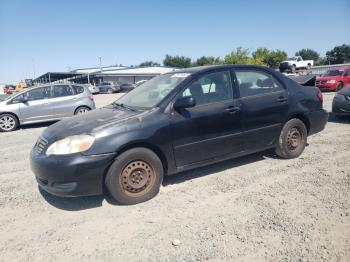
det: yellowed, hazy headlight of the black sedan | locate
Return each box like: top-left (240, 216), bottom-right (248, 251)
top-left (46, 135), bottom-right (95, 156)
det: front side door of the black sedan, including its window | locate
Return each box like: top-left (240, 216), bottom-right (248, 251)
top-left (170, 71), bottom-right (243, 167)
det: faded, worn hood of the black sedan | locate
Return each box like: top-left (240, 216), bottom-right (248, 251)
top-left (42, 105), bottom-right (150, 142)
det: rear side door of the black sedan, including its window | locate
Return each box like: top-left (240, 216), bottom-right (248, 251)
top-left (235, 68), bottom-right (290, 151)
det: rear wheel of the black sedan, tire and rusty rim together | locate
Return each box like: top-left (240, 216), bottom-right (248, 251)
top-left (275, 118), bottom-right (307, 159)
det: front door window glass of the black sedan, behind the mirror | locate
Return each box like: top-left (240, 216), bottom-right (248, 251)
top-left (182, 71), bottom-right (233, 105)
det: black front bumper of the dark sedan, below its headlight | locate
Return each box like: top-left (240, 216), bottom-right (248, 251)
top-left (30, 149), bottom-right (115, 197)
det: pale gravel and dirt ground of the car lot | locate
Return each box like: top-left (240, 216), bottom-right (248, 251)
top-left (0, 93), bottom-right (350, 261)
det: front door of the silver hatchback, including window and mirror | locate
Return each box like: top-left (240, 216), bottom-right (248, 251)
top-left (17, 86), bottom-right (53, 123)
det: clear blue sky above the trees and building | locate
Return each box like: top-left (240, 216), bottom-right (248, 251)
top-left (0, 0), bottom-right (350, 83)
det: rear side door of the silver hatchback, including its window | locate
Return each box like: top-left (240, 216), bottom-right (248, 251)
top-left (52, 85), bottom-right (78, 118)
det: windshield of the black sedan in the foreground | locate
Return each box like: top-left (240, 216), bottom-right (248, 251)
top-left (116, 73), bottom-right (190, 108)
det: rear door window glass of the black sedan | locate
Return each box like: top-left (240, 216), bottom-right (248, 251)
top-left (235, 70), bottom-right (283, 97)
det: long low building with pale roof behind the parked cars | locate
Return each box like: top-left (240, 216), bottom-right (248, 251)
top-left (34, 66), bottom-right (177, 84)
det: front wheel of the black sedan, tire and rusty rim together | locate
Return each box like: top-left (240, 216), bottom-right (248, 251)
top-left (105, 147), bottom-right (164, 205)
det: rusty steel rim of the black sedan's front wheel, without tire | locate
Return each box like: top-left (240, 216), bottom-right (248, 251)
top-left (119, 160), bottom-right (156, 197)
